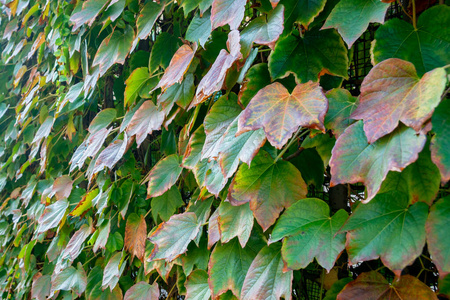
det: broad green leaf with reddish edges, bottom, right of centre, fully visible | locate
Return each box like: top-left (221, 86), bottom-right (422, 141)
top-left (270, 198), bottom-right (348, 272)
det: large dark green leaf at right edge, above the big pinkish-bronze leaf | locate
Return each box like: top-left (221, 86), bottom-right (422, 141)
top-left (371, 5), bottom-right (450, 75)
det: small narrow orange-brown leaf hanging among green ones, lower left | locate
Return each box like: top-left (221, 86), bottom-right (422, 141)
top-left (125, 213), bottom-right (147, 261)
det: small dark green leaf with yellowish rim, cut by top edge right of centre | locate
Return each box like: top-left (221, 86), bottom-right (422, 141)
top-left (280, 0), bottom-right (327, 31)
